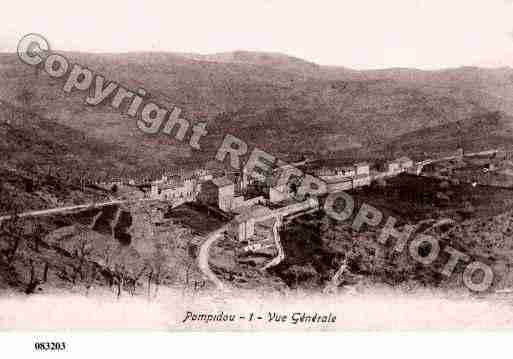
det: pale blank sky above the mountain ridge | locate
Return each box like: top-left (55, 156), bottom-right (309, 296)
top-left (0, 0), bottom-right (513, 69)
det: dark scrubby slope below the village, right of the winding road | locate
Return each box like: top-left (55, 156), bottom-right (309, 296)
top-left (274, 175), bottom-right (513, 289)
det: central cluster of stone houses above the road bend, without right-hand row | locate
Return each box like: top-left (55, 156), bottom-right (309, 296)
top-left (148, 165), bottom-right (324, 246)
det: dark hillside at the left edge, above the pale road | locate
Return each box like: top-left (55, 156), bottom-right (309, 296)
top-left (0, 102), bottom-right (125, 214)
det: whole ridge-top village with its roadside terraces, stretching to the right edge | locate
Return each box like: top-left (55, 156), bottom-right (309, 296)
top-left (77, 145), bottom-right (510, 272)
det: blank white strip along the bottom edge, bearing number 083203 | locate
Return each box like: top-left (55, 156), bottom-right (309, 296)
top-left (0, 332), bottom-right (506, 359)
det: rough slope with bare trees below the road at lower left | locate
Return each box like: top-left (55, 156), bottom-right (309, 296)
top-left (0, 201), bottom-right (210, 299)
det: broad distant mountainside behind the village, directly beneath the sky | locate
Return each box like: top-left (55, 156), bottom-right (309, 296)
top-left (0, 51), bottom-right (513, 167)
